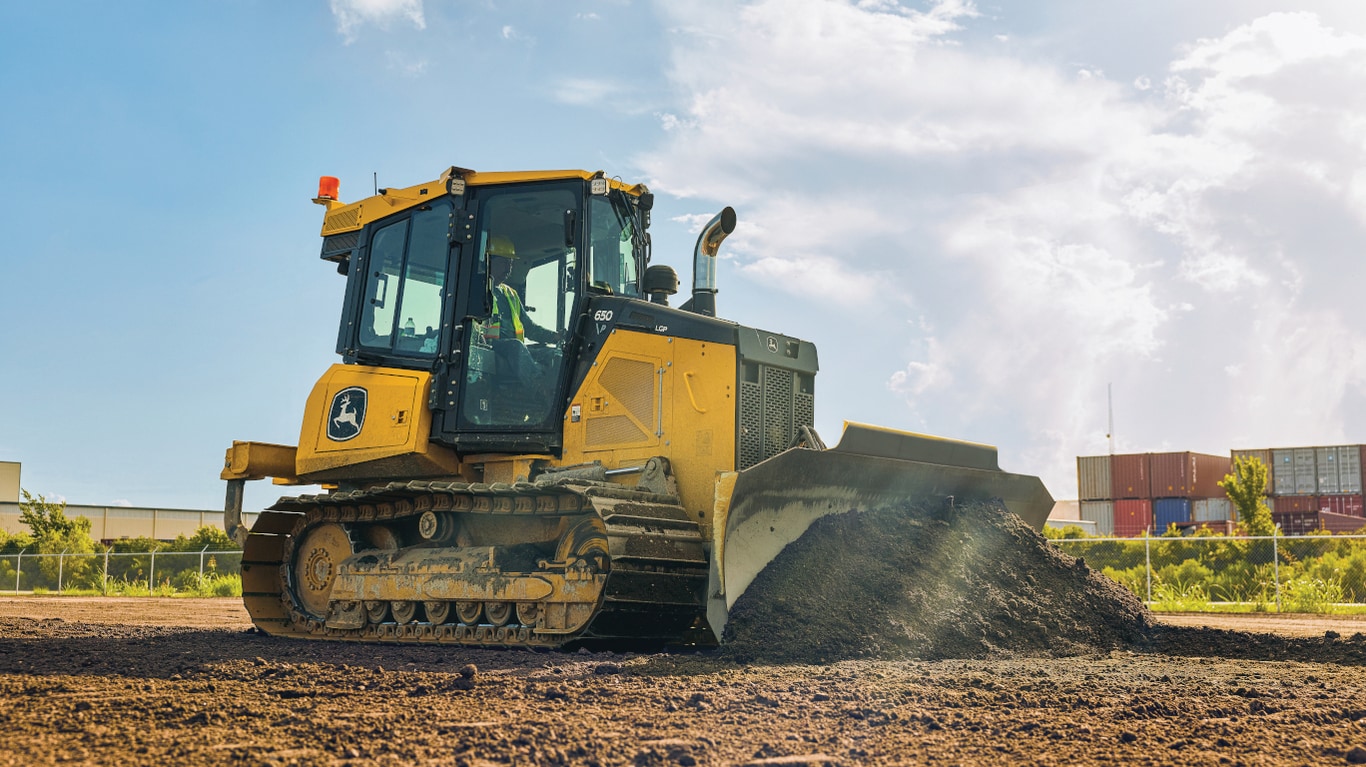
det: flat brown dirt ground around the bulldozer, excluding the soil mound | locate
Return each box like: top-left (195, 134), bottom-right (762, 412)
top-left (0, 597), bottom-right (1366, 766)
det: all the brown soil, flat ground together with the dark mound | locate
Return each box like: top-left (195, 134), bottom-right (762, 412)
top-left (8, 500), bottom-right (1366, 766)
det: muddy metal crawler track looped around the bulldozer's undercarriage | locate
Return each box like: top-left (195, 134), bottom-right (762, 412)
top-left (242, 481), bottom-right (708, 647)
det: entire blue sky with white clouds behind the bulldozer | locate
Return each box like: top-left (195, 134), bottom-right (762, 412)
top-left (0, 0), bottom-right (1366, 509)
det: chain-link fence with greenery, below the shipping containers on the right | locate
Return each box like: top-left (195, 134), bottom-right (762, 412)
top-left (1052, 535), bottom-right (1366, 613)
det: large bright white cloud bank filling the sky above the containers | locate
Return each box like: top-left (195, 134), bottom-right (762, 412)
top-left (641, 0), bottom-right (1366, 496)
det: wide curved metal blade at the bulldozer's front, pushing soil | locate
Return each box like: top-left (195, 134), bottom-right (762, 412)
top-left (708, 424), bottom-right (1053, 641)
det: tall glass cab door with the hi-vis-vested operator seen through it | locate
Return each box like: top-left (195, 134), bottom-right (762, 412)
top-left (460, 185), bottom-right (578, 429)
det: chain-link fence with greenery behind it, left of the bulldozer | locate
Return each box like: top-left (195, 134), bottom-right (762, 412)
top-left (0, 548), bottom-right (242, 596)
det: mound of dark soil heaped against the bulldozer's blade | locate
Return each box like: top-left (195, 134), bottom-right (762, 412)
top-left (723, 503), bottom-right (1150, 663)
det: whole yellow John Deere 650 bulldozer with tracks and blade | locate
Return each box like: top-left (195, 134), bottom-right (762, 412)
top-left (221, 167), bottom-right (1053, 647)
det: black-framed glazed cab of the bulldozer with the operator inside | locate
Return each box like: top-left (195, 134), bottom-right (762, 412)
top-left (324, 178), bottom-right (646, 453)
